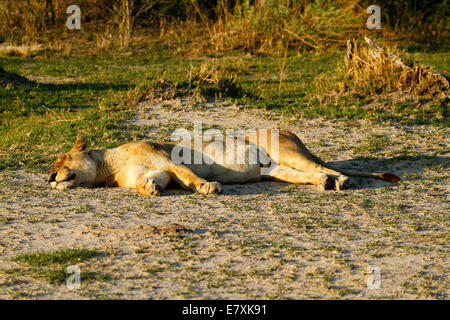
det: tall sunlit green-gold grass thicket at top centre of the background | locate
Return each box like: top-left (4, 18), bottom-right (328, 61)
top-left (161, 0), bottom-right (364, 53)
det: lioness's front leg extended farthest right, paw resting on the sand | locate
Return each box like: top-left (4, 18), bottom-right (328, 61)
top-left (169, 164), bottom-right (222, 194)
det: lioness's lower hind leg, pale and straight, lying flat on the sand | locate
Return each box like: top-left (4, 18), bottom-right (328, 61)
top-left (269, 166), bottom-right (334, 191)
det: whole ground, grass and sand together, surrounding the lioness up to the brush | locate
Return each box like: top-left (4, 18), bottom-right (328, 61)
top-left (0, 2), bottom-right (450, 299)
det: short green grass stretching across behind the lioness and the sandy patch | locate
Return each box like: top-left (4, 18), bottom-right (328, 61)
top-left (0, 39), bottom-right (450, 172)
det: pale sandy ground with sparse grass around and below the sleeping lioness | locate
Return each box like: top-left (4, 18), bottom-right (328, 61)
top-left (0, 98), bottom-right (450, 299)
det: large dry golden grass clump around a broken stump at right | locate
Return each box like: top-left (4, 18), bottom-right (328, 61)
top-left (325, 40), bottom-right (450, 123)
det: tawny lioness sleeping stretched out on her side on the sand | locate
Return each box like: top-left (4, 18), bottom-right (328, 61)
top-left (48, 129), bottom-right (400, 196)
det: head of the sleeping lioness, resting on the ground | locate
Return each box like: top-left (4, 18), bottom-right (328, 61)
top-left (48, 137), bottom-right (97, 190)
